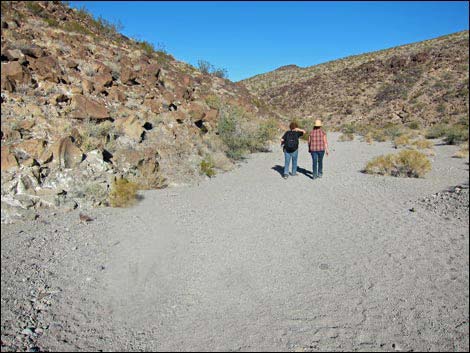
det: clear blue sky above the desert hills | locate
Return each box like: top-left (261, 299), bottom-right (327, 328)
top-left (70, 1), bottom-right (469, 81)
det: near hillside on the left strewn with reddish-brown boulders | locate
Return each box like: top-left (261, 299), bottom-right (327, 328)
top-left (1, 1), bottom-right (280, 222)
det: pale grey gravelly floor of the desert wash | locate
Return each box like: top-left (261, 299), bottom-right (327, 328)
top-left (1, 134), bottom-right (469, 351)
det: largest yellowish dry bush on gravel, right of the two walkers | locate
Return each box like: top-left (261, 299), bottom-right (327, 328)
top-left (364, 150), bottom-right (431, 178)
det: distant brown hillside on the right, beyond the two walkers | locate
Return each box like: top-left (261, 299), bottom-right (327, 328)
top-left (242, 31), bottom-right (469, 126)
